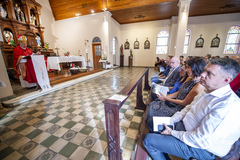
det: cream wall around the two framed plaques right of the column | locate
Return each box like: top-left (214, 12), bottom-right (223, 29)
top-left (188, 13), bottom-right (240, 57)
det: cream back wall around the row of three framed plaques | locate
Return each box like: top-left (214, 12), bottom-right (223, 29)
top-left (121, 20), bottom-right (171, 66)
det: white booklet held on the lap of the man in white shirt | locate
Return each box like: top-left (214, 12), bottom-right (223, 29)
top-left (153, 117), bottom-right (174, 132)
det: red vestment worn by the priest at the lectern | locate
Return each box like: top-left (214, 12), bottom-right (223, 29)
top-left (13, 45), bottom-right (37, 83)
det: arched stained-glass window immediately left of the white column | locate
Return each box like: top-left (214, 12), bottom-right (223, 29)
top-left (156, 31), bottom-right (169, 54)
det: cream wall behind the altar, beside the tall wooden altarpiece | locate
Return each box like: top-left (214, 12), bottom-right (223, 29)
top-left (56, 13), bottom-right (108, 67)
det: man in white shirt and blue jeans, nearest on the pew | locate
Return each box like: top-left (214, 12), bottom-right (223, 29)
top-left (143, 58), bottom-right (240, 160)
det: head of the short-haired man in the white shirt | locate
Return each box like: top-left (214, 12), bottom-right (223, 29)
top-left (201, 58), bottom-right (239, 92)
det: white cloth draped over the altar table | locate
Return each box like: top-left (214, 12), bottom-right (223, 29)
top-left (47, 56), bottom-right (86, 71)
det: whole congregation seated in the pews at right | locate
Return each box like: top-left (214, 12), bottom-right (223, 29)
top-left (143, 54), bottom-right (240, 160)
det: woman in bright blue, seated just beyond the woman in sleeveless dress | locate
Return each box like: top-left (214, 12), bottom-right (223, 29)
top-left (151, 65), bottom-right (188, 101)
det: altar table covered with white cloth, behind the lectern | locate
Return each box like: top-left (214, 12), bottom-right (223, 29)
top-left (47, 56), bottom-right (86, 71)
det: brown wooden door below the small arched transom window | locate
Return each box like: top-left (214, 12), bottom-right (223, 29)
top-left (92, 43), bottom-right (102, 68)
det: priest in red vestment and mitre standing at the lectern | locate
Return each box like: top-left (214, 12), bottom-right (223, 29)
top-left (13, 35), bottom-right (37, 87)
